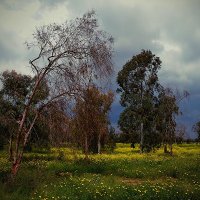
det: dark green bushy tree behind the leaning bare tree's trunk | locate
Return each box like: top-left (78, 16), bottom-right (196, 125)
top-left (0, 70), bottom-right (49, 157)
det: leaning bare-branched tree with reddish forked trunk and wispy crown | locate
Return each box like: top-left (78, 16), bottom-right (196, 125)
top-left (12, 11), bottom-right (113, 175)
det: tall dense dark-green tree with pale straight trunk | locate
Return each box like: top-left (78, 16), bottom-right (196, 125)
top-left (117, 50), bottom-right (161, 152)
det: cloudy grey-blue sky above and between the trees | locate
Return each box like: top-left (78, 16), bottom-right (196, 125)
top-left (0, 0), bottom-right (200, 138)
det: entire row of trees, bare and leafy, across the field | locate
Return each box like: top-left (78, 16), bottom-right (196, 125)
top-left (0, 11), bottom-right (197, 175)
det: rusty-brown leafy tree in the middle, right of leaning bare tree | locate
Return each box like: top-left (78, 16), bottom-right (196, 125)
top-left (74, 86), bottom-right (113, 158)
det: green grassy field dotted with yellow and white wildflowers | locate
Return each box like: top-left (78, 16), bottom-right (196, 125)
top-left (0, 144), bottom-right (200, 200)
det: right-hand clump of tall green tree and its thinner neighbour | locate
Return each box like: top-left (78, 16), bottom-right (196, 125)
top-left (117, 50), bottom-right (189, 155)
